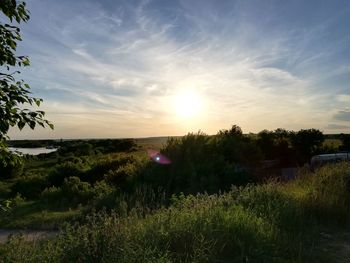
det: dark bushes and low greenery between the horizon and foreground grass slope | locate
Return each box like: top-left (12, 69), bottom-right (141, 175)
top-left (0, 126), bottom-right (346, 228)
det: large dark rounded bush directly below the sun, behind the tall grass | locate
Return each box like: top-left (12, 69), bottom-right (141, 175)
top-left (137, 132), bottom-right (256, 194)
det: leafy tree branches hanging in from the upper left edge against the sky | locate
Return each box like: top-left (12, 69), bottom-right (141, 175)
top-left (0, 0), bottom-right (53, 166)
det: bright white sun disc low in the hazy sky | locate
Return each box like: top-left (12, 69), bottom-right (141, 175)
top-left (174, 90), bottom-right (201, 119)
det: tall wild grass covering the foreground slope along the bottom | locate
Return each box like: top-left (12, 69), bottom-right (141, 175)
top-left (0, 163), bottom-right (350, 262)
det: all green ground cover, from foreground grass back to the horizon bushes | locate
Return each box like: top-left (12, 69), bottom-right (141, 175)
top-left (0, 126), bottom-right (350, 262)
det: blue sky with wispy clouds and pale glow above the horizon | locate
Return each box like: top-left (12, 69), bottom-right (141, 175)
top-left (6, 0), bottom-right (350, 139)
